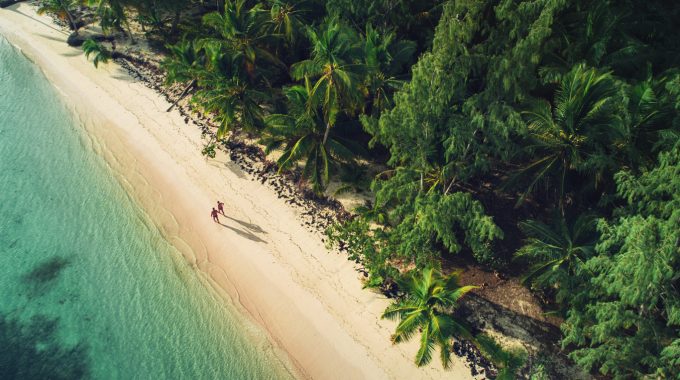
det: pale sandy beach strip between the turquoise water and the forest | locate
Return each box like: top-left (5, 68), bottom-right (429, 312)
top-left (0, 3), bottom-right (471, 379)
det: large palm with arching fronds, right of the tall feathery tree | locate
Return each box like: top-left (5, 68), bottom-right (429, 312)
top-left (513, 65), bottom-right (620, 213)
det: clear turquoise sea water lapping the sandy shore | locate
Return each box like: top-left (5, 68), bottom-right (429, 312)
top-left (0, 36), bottom-right (290, 379)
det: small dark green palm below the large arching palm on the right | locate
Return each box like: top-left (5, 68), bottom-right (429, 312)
top-left (515, 214), bottom-right (597, 301)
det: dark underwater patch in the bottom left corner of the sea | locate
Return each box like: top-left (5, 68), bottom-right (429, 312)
top-left (0, 314), bottom-right (90, 380)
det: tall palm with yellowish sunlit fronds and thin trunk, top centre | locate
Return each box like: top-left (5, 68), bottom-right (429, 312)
top-left (290, 20), bottom-right (362, 145)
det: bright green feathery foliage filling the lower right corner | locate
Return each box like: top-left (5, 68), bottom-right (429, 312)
top-left (563, 143), bottom-right (680, 378)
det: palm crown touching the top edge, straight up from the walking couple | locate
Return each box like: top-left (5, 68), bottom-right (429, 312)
top-left (202, 0), bottom-right (285, 80)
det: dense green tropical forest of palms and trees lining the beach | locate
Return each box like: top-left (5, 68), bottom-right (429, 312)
top-left (46, 0), bottom-right (680, 378)
